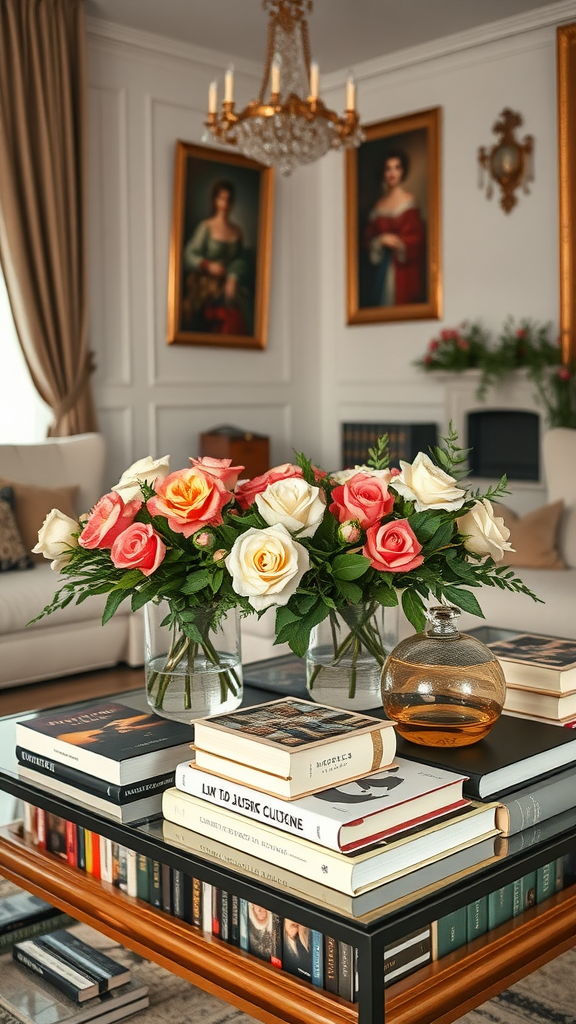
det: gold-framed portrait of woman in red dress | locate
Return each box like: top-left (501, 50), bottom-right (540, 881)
top-left (346, 106), bottom-right (442, 324)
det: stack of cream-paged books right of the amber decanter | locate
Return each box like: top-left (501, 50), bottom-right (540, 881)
top-left (489, 633), bottom-right (576, 728)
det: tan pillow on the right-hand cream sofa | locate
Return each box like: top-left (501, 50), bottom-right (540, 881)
top-left (493, 502), bottom-right (566, 569)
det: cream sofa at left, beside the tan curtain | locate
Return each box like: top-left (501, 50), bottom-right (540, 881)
top-left (0, 433), bottom-right (143, 687)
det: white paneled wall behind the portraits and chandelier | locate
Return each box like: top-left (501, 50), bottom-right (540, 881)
top-left (85, 0), bottom-right (565, 483)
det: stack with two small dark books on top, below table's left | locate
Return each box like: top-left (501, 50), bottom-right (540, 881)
top-left (0, 929), bottom-right (150, 1024)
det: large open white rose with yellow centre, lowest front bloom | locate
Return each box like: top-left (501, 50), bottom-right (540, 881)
top-left (225, 524), bottom-right (310, 611)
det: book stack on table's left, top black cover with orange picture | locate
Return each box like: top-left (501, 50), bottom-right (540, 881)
top-left (16, 702), bottom-right (194, 827)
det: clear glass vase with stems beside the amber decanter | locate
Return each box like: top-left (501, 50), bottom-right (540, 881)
top-left (306, 601), bottom-right (398, 711)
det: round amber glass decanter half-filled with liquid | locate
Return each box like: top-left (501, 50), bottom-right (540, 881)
top-left (382, 605), bottom-right (506, 746)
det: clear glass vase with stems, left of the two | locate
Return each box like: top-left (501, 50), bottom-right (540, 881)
top-left (145, 601), bottom-right (242, 722)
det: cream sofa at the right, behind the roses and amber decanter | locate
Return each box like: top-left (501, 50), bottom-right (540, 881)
top-left (242, 428), bottom-right (576, 662)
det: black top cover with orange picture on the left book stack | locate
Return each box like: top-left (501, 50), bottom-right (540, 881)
top-left (16, 702), bottom-right (193, 762)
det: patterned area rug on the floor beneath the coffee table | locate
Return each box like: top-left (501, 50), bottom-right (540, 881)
top-left (0, 879), bottom-right (576, 1024)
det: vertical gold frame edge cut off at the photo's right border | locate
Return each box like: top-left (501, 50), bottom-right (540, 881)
top-left (557, 23), bottom-right (576, 362)
